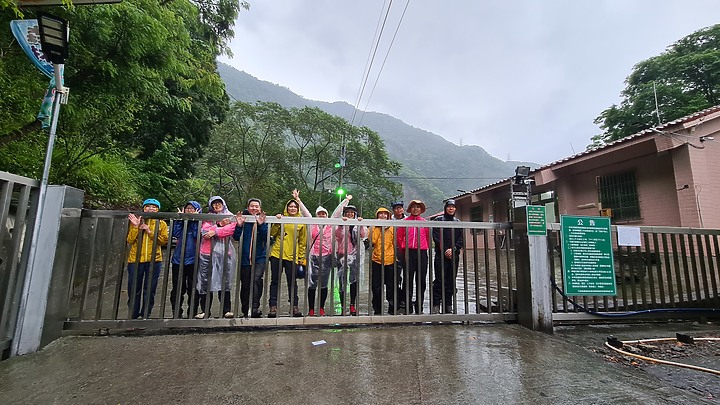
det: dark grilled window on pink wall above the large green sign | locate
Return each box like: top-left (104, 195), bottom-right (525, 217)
top-left (597, 172), bottom-right (640, 221)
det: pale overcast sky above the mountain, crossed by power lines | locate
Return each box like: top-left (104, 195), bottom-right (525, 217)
top-left (221, 0), bottom-right (720, 164)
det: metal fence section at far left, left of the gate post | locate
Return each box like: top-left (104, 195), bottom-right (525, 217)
top-left (0, 172), bottom-right (40, 357)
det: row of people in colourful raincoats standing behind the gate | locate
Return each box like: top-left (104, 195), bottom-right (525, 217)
top-left (127, 190), bottom-right (462, 319)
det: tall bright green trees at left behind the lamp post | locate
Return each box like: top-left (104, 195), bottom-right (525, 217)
top-left (0, 0), bottom-right (248, 206)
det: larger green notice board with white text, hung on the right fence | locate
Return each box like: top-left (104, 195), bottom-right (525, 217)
top-left (560, 215), bottom-right (617, 295)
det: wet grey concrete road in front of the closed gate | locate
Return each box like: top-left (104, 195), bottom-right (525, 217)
top-left (0, 325), bottom-right (704, 405)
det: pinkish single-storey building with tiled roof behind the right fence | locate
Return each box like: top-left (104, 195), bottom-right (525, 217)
top-left (453, 105), bottom-right (720, 234)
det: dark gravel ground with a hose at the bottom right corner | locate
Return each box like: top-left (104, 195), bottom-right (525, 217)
top-left (555, 323), bottom-right (720, 402)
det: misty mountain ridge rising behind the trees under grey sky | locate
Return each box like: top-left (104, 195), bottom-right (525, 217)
top-left (218, 62), bottom-right (539, 213)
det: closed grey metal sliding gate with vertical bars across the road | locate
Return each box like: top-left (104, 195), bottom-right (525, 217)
top-left (64, 210), bottom-right (517, 332)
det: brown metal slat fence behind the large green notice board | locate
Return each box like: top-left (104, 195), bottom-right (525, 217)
top-left (548, 224), bottom-right (720, 320)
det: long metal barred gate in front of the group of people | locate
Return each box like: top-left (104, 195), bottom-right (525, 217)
top-left (60, 210), bottom-right (517, 330)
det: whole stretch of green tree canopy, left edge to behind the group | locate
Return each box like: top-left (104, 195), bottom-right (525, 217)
top-left (0, 0), bottom-right (402, 215)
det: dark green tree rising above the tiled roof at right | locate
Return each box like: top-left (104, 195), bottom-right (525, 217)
top-left (590, 25), bottom-right (720, 147)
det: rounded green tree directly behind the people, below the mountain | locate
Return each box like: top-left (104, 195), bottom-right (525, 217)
top-left (188, 102), bottom-right (402, 213)
